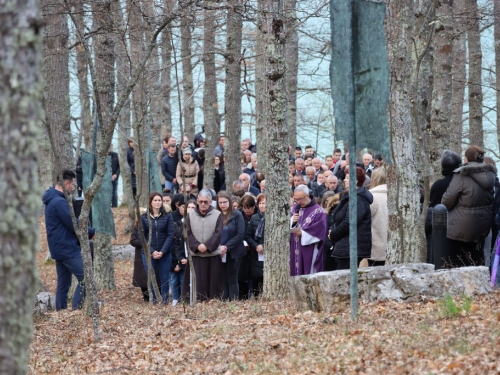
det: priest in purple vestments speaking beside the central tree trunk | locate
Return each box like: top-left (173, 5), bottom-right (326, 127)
top-left (290, 185), bottom-right (328, 276)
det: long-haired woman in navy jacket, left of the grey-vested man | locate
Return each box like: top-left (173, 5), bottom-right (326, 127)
top-left (141, 191), bottom-right (174, 303)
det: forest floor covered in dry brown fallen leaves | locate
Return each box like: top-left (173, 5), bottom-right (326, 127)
top-left (30, 210), bottom-right (500, 375)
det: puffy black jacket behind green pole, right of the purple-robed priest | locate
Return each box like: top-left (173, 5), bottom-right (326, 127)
top-left (330, 186), bottom-right (373, 258)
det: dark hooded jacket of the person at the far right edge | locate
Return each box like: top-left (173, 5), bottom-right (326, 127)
top-left (441, 162), bottom-right (497, 242)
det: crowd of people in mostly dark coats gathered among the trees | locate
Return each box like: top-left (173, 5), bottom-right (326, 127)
top-left (44, 134), bottom-right (500, 308)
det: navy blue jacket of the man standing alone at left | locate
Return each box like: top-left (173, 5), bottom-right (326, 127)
top-left (42, 187), bottom-right (95, 260)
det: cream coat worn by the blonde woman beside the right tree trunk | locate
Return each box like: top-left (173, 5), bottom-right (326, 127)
top-left (370, 184), bottom-right (389, 261)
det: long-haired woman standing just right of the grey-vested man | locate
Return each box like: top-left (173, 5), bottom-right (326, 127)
top-left (217, 191), bottom-right (246, 300)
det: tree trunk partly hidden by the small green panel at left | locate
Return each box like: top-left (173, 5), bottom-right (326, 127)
top-left (92, 2), bottom-right (116, 290)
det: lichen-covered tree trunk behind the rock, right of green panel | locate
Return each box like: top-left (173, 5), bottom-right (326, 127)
top-left (386, 0), bottom-right (425, 264)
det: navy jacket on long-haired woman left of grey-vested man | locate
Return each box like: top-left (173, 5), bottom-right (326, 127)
top-left (141, 207), bottom-right (175, 254)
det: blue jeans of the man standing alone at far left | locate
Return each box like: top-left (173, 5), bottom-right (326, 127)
top-left (56, 256), bottom-right (85, 310)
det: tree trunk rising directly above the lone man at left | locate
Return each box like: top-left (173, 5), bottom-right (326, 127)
top-left (41, 0), bottom-right (76, 181)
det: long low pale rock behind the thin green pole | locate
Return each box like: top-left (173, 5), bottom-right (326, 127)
top-left (290, 263), bottom-right (492, 312)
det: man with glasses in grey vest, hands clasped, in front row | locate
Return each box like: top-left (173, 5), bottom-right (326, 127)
top-left (182, 189), bottom-right (223, 301)
